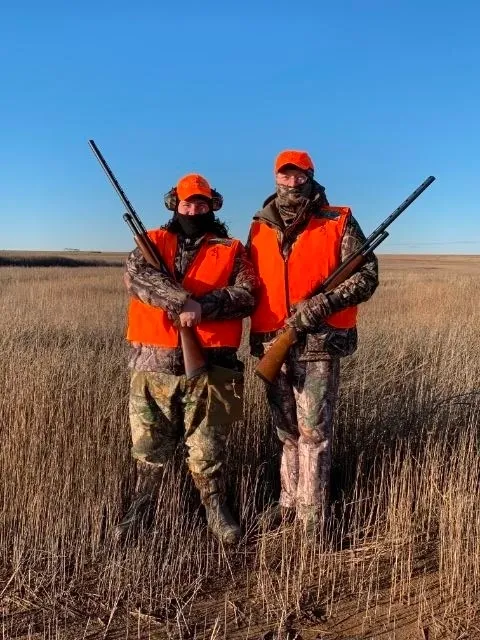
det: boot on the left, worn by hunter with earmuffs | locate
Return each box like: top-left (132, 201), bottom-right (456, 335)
top-left (113, 460), bottom-right (163, 543)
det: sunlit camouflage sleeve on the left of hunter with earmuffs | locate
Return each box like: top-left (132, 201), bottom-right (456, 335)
top-left (124, 248), bottom-right (189, 315)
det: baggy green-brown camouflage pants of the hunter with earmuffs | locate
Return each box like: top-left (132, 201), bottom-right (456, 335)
top-left (129, 370), bottom-right (230, 476)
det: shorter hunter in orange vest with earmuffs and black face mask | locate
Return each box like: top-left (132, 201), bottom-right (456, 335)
top-left (115, 174), bottom-right (257, 544)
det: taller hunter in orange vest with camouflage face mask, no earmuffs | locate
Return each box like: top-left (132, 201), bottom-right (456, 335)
top-left (247, 150), bottom-right (378, 535)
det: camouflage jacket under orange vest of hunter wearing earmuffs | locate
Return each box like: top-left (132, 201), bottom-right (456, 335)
top-left (124, 234), bottom-right (258, 375)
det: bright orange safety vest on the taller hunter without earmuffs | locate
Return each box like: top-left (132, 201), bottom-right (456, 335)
top-left (250, 207), bottom-right (357, 333)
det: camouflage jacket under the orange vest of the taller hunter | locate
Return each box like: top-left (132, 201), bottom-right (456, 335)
top-left (247, 194), bottom-right (378, 361)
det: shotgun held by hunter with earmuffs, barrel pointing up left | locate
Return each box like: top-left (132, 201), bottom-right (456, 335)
top-left (88, 140), bottom-right (207, 380)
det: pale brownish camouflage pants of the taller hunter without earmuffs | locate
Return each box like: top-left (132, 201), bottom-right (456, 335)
top-left (267, 347), bottom-right (340, 516)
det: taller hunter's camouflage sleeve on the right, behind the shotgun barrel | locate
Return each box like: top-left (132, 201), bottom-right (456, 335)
top-left (288, 216), bottom-right (378, 332)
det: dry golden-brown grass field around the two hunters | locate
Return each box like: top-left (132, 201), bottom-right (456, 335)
top-left (0, 253), bottom-right (480, 640)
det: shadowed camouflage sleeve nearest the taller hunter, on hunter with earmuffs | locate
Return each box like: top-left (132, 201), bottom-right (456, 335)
top-left (197, 244), bottom-right (258, 320)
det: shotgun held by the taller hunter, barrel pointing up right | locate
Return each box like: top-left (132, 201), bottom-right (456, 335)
top-left (255, 176), bottom-right (435, 384)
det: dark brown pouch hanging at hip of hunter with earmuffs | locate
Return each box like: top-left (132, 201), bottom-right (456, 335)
top-left (206, 365), bottom-right (244, 425)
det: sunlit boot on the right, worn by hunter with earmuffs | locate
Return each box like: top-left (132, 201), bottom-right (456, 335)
top-left (192, 473), bottom-right (242, 544)
